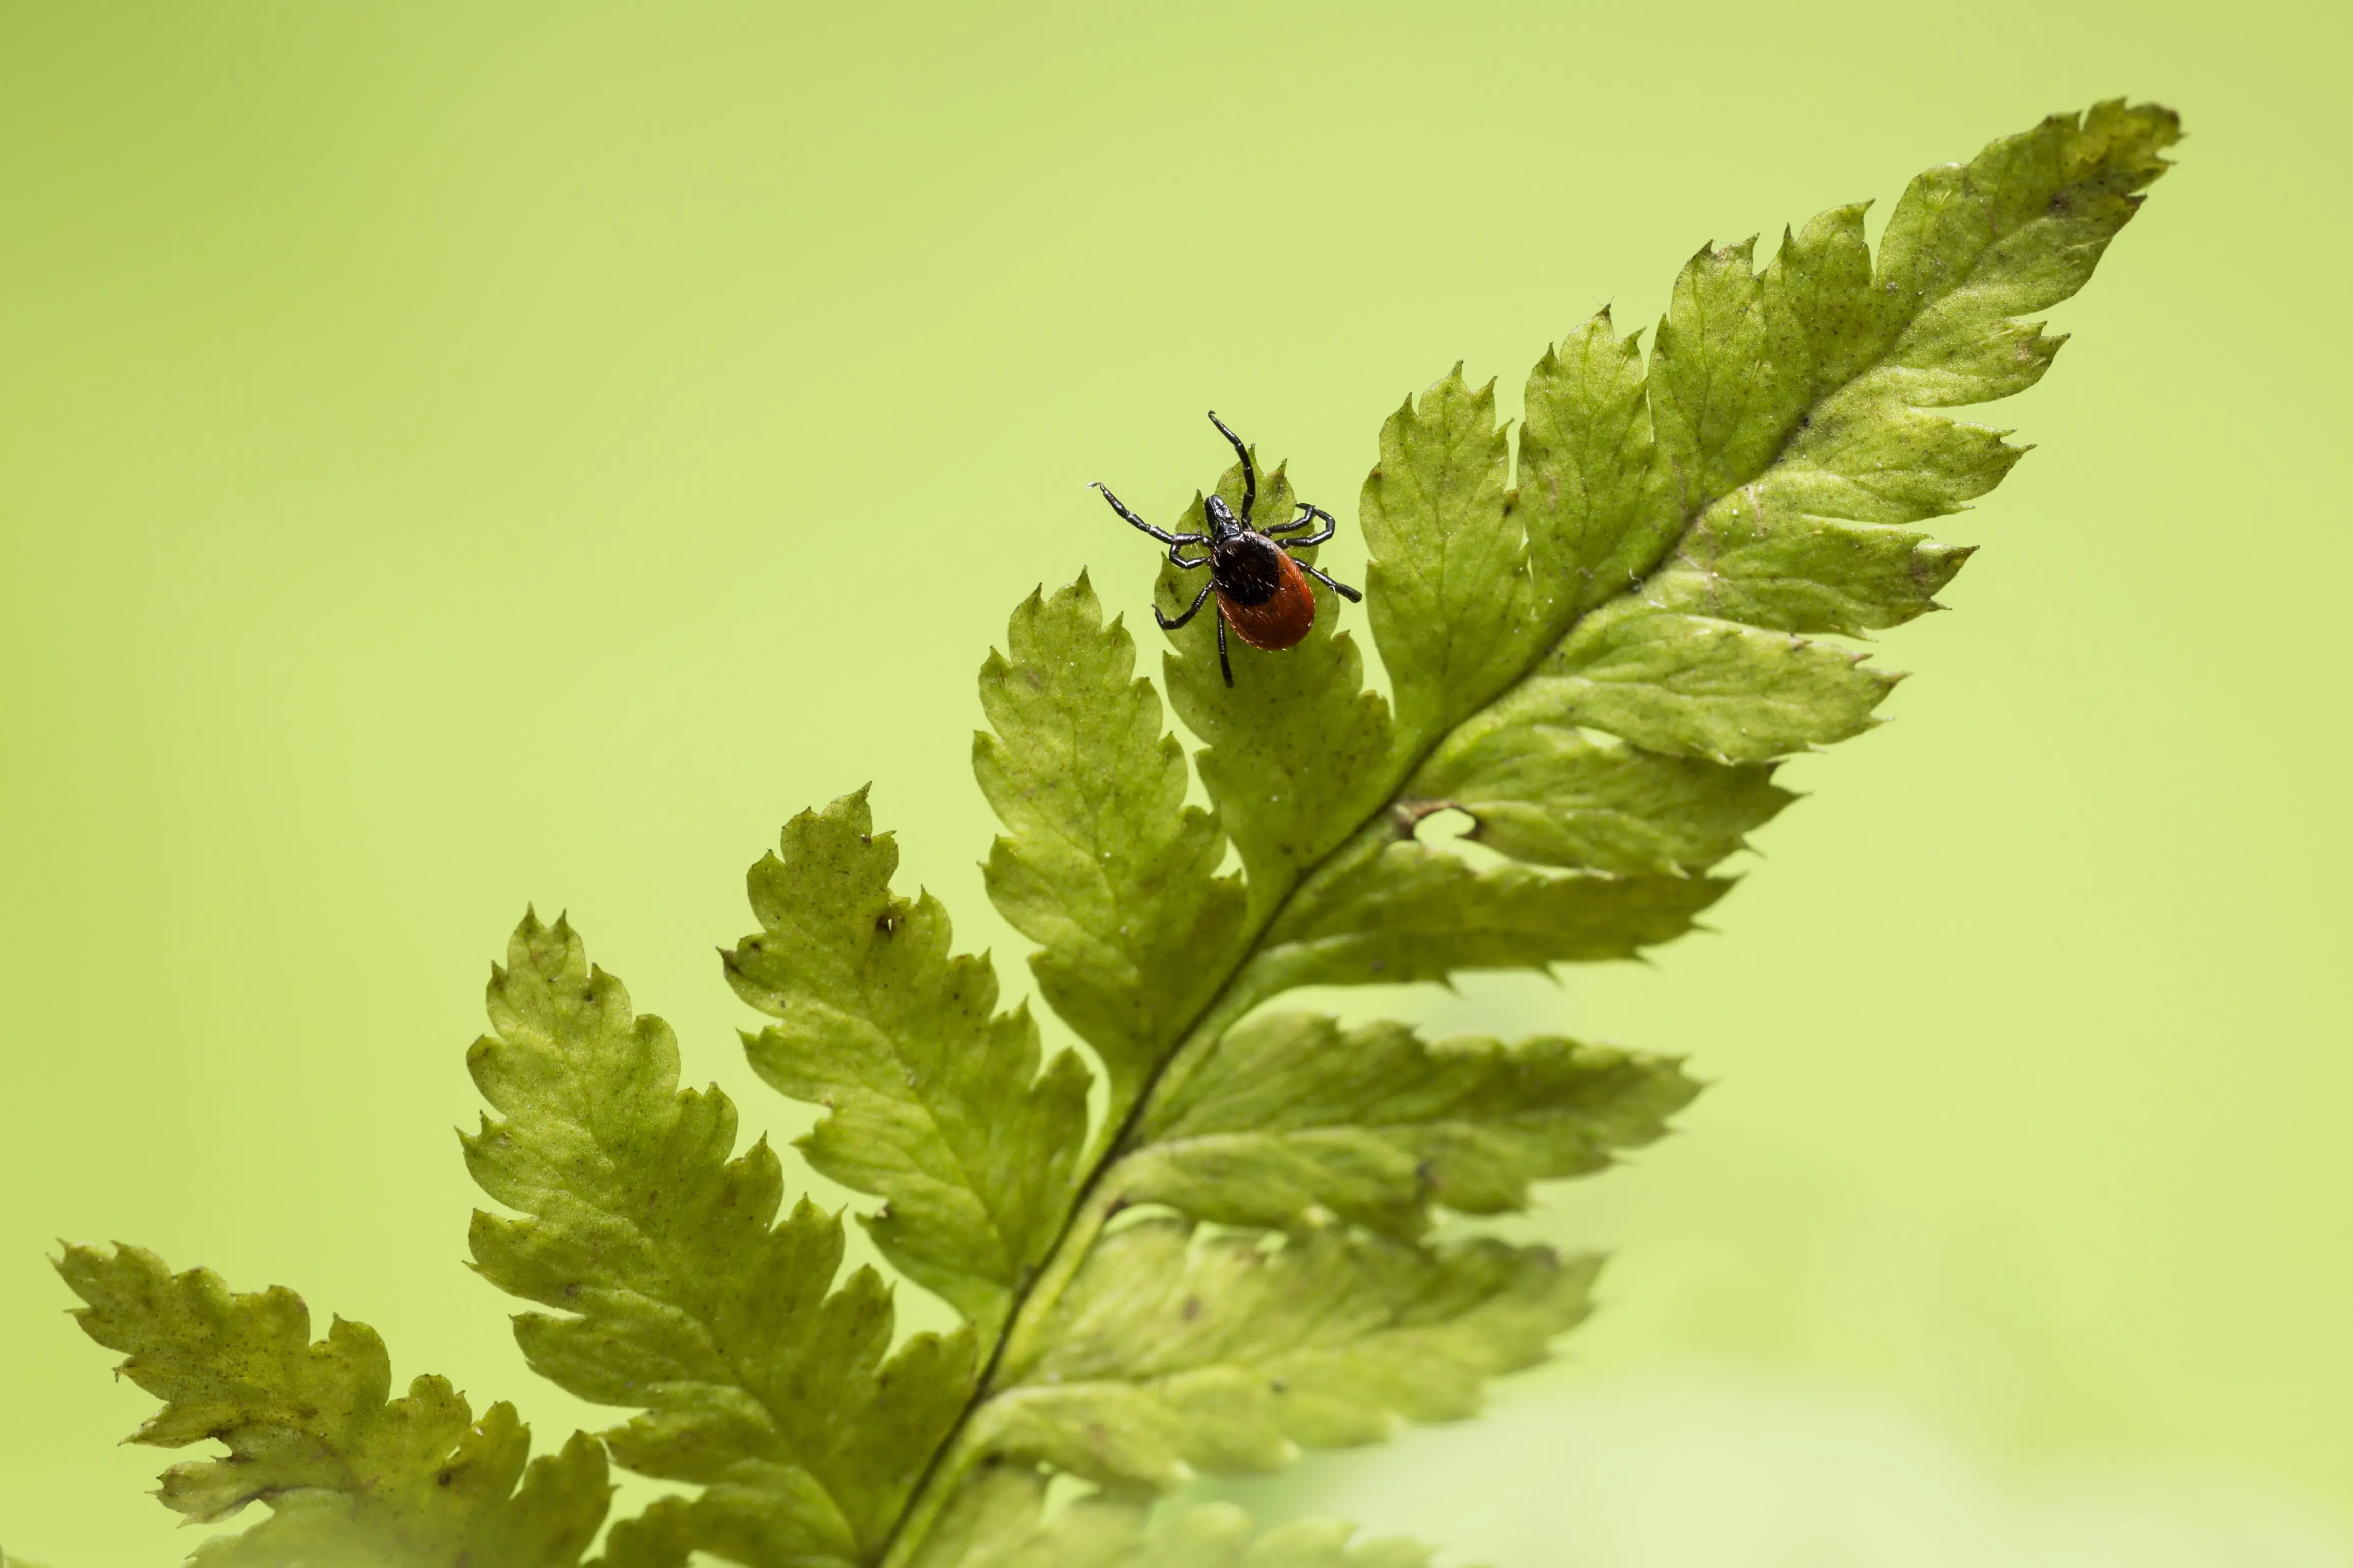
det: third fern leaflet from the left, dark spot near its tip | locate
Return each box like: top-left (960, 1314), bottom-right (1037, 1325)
top-left (725, 790), bottom-right (1089, 1335)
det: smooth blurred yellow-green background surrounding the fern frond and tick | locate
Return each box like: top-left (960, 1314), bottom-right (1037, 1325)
top-left (0, 0), bottom-right (2353, 1568)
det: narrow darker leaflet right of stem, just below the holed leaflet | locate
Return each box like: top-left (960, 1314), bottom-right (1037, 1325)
top-left (1236, 828), bottom-right (1732, 1002)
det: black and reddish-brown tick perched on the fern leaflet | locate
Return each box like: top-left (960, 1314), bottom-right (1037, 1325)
top-left (1094, 411), bottom-right (1365, 687)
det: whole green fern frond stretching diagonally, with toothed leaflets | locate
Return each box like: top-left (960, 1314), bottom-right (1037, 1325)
top-left (55, 101), bottom-right (2179, 1568)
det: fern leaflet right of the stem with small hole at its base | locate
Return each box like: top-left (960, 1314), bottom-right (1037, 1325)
top-left (1405, 710), bottom-right (1796, 877)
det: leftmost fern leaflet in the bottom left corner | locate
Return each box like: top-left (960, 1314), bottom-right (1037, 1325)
top-left (57, 1246), bottom-right (612, 1568)
